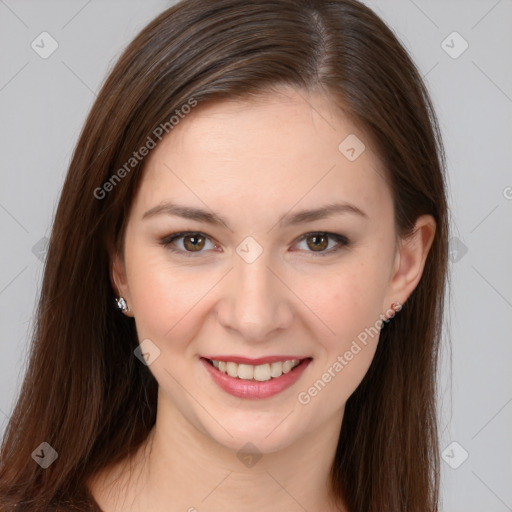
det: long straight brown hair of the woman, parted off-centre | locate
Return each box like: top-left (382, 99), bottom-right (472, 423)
top-left (0, 0), bottom-right (448, 512)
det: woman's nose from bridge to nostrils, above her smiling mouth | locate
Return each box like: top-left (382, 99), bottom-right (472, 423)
top-left (217, 252), bottom-right (294, 342)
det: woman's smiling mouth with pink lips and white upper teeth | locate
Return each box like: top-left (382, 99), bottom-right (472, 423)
top-left (201, 356), bottom-right (312, 399)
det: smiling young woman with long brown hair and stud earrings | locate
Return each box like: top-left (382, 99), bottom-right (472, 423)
top-left (0, 0), bottom-right (448, 512)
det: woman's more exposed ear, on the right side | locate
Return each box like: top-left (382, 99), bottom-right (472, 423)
top-left (383, 215), bottom-right (436, 311)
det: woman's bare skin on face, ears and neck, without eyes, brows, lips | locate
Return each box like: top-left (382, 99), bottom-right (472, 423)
top-left (90, 88), bottom-right (435, 512)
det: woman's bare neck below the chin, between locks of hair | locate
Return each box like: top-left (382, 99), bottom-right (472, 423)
top-left (89, 393), bottom-right (346, 512)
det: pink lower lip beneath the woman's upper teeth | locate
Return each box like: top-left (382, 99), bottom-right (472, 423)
top-left (201, 358), bottom-right (311, 399)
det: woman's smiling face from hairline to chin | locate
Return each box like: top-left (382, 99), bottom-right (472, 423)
top-left (113, 89), bottom-right (432, 452)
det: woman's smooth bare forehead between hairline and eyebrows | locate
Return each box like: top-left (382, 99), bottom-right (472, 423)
top-left (134, 89), bottom-right (391, 222)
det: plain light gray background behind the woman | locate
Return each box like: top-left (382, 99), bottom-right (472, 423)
top-left (0, 0), bottom-right (512, 512)
